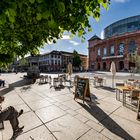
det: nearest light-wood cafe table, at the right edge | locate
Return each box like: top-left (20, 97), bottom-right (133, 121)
top-left (116, 86), bottom-right (140, 106)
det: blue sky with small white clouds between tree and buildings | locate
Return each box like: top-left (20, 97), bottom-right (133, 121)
top-left (40, 0), bottom-right (140, 55)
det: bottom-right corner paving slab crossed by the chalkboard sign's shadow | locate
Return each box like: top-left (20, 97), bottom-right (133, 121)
top-left (101, 114), bottom-right (140, 139)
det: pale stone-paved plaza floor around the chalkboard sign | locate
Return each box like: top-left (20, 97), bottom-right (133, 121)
top-left (0, 72), bottom-right (140, 140)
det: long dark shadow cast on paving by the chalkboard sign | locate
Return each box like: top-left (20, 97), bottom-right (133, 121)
top-left (78, 102), bottom-right (134, 140)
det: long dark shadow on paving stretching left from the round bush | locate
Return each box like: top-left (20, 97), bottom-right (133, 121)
top-left (0, 79), bottom-right (32, 96)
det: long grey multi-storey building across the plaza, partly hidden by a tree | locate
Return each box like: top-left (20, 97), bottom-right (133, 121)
top-left (28, 51), bottom-right (88, 72)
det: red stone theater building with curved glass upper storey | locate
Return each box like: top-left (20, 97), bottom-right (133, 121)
top-left (88, 15), bottom-right (140, 71)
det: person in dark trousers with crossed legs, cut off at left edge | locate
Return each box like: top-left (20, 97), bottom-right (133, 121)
top-left (0, 96), bottom-right (24, 138)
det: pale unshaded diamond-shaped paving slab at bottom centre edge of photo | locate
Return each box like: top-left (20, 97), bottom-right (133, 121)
top-left (46, 115), bottom-right (90, 140)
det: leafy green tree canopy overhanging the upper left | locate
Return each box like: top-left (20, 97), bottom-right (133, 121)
top-left (0, 0), bottom-right (109, 65)
